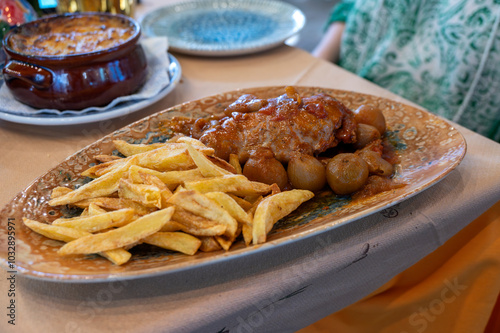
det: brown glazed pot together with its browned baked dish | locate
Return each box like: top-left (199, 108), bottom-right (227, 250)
top-left (3, 13), bottom-right (147, 110)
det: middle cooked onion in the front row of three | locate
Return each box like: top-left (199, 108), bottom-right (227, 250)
top-left (287, 154), bottom-right (326, 192)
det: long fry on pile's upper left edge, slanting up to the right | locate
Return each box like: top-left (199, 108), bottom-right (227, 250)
top-left (49, 159), bottom-right (135, 206)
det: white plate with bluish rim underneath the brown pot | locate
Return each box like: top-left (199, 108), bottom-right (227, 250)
top-left (0, 54), bottom-right (181, 126)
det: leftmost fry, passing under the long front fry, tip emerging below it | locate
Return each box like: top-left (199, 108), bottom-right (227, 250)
top-left (23, 217), bottom-right (132, 265)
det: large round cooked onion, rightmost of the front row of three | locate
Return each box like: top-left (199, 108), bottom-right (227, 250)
top-left (326, 153), bottom-right (369, 195)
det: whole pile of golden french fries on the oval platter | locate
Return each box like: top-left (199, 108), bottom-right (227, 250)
top-left (23, 136), bottom-right (314, 265)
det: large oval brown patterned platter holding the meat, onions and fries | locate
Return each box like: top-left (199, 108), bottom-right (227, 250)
top-left (0, 87), bottom-right (466, 282)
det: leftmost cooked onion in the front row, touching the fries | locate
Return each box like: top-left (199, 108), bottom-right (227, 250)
top-left (243, 148), bottom-right (288, 190)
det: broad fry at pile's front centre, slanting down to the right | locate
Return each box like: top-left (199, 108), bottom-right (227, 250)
top-left (168, 191), bottom-right (238, 237)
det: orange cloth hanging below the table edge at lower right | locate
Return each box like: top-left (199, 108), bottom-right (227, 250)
top-left (299, 202), bottom-right (500, 333)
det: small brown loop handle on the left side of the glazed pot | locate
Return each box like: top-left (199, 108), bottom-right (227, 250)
top-left (3, 60), bottom-right (53, 89)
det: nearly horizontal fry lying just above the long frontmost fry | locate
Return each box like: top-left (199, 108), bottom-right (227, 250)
top-left (52, 208), bottom-right (136, 232)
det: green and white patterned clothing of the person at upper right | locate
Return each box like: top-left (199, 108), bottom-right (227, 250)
top-left (330, 0), bottom-right (500, 142)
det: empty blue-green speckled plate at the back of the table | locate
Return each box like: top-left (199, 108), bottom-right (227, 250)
top-left (142, 0), bottom-right (305, 56)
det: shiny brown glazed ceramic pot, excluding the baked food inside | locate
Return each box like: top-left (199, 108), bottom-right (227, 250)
top-left (3, 13), bottom-right (147, 110)
